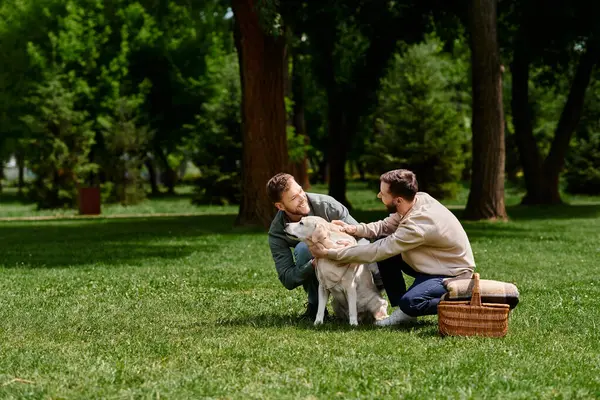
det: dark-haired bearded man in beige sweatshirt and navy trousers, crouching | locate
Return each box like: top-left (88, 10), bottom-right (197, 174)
top-left (310, 169), bottom-right (475, 326)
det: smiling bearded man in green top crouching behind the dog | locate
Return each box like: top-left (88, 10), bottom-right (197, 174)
top-left (267, 173), bottom-right (379, 319)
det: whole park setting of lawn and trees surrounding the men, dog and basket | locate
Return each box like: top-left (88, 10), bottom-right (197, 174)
top-left (0, 0), bottom-right (600, 399)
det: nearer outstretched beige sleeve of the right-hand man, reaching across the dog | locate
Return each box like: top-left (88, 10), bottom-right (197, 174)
top-left (327, 220), bottom-right (425, 263)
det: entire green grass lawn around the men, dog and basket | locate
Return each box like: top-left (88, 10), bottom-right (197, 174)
top-left (0, 186), bottom-right (600, 399)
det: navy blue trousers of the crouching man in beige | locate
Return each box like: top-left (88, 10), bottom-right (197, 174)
top-left (377, 255), bottom-right (448, 317)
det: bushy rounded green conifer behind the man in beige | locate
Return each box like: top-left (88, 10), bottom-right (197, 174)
top-left (364, 39), bottom-right (470, 197)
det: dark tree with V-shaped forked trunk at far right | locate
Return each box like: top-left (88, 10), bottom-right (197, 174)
top-left (511, 2), bottom-right (600, 204)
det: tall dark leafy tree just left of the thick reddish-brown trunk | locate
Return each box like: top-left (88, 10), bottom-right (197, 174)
top-left (130, 0), bottom-right (233, 194)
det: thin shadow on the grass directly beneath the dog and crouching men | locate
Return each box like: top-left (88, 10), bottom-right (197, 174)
top-left (216, 313), bottom-right (437, 336)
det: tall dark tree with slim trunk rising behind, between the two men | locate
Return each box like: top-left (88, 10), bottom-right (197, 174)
top-left (286, 0), bottom-right (428, 207)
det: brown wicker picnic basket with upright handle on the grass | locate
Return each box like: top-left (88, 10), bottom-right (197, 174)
top-left (438, 274), bottom-right (510, 337)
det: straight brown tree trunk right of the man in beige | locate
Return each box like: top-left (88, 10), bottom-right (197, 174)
top-left (464, 0), bottom-right (506, 220)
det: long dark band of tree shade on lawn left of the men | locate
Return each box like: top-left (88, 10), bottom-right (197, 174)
top-left (0, 215), bottom-right (266, 268)
